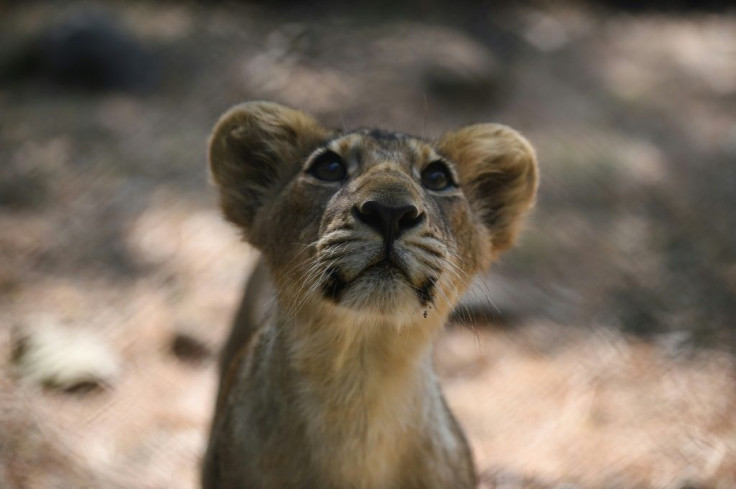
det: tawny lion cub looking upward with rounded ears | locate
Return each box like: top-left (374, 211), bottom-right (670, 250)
top-left (203, 102), bottom-right (537, 489)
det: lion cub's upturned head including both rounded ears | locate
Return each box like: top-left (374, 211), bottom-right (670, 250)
top-left (209, 102), bottom-right (537, 320)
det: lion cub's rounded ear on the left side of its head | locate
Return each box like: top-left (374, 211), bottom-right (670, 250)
top-left (209, 102), bottom-right (329, 237)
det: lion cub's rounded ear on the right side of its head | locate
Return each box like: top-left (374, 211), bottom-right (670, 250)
top-left (439, 124), bottom-right (538, 256)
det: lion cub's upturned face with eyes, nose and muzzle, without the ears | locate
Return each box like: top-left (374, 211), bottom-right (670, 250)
top-left (288, 127), bottom-right (474, 314)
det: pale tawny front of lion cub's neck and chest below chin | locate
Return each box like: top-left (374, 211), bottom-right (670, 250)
top-left (280, 306), bottom-right (441, 487)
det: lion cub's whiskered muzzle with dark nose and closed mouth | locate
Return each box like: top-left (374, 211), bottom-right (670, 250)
top-left (317, 177), bottom-right (447, 313)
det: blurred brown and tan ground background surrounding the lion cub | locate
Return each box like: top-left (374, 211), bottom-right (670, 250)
top-left (0, 0), bottom-right (736, 489)
